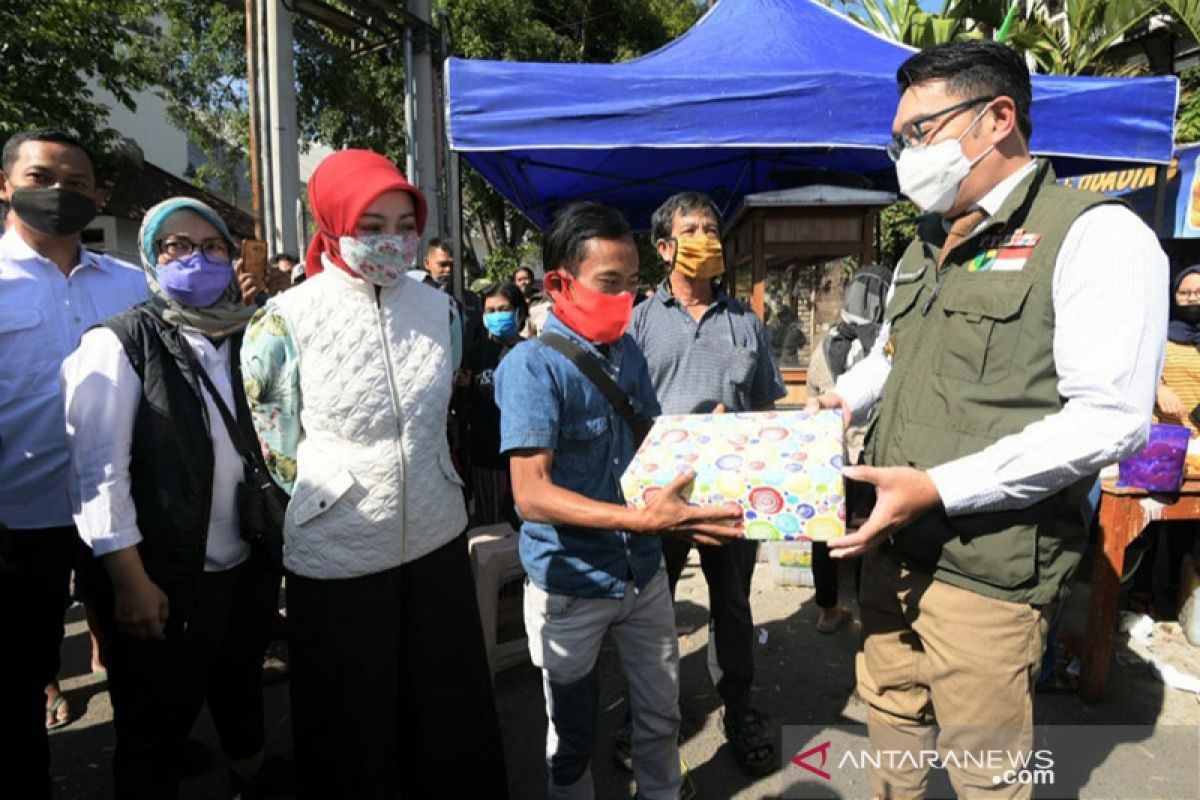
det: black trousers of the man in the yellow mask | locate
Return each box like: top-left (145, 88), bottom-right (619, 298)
top-left (662, 537), bottom-right (758, 714)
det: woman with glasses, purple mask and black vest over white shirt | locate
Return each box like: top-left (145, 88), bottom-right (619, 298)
top-left (61, 198), bottom-right (278, 799)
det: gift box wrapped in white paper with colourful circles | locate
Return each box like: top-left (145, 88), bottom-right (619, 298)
top-left (620, 411), bottom-right (846, 542)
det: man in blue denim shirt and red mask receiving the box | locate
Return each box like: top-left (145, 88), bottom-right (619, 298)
top-left (496, 203), bottom-right (740, 800)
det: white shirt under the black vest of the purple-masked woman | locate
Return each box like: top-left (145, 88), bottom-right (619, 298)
top-left (62, 327), bottom-right (250, 572)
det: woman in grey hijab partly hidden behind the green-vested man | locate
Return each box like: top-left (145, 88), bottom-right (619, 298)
top-left (808, 265), bottom-right (892, 633)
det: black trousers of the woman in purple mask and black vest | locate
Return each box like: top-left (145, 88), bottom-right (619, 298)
top-left (96, 559), bottom-right (278, 800)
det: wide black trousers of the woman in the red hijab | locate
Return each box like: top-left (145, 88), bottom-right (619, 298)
top-left (288, 534), bottom-right (508, 800)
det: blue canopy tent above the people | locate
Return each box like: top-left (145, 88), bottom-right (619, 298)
top-left (446, 0), bottom-right (1177, 229)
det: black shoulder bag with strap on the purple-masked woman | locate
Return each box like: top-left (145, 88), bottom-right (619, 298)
top-left (184, 352), bottom-right (288, 572)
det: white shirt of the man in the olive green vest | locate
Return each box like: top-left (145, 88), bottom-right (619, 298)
top-left (834, 162), bottom-right (1169, 516)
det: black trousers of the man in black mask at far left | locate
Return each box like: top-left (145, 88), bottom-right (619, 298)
top-left (0, 527), bottom-right (83, 798)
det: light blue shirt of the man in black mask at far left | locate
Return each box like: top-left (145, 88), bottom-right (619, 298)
top-left (0, 229), bottom-right (146, 529)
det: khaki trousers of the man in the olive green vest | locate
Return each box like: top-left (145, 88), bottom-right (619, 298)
top-left (856, 549), bottom-right (1049, 798)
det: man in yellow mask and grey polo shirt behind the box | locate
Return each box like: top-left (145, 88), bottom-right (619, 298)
top-left (618, 192), bottom-right (787, 776)
